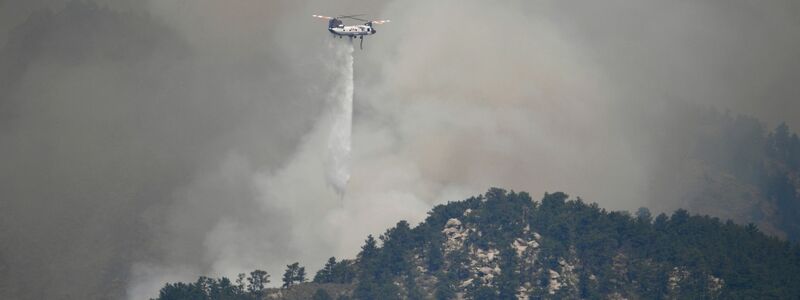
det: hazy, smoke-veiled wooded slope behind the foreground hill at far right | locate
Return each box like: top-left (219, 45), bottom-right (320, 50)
top-left (664, 110), bottom-right (800, 241)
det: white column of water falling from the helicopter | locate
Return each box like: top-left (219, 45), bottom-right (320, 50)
top-left (325, 41), bottom-right (353, 195)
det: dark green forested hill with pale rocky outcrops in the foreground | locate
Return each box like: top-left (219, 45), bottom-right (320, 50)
top-left (158, 188), bottom-right (800, 300)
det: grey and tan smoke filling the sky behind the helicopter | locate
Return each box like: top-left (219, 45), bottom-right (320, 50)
top-left (0, 0), bottom-right (800, 299)
